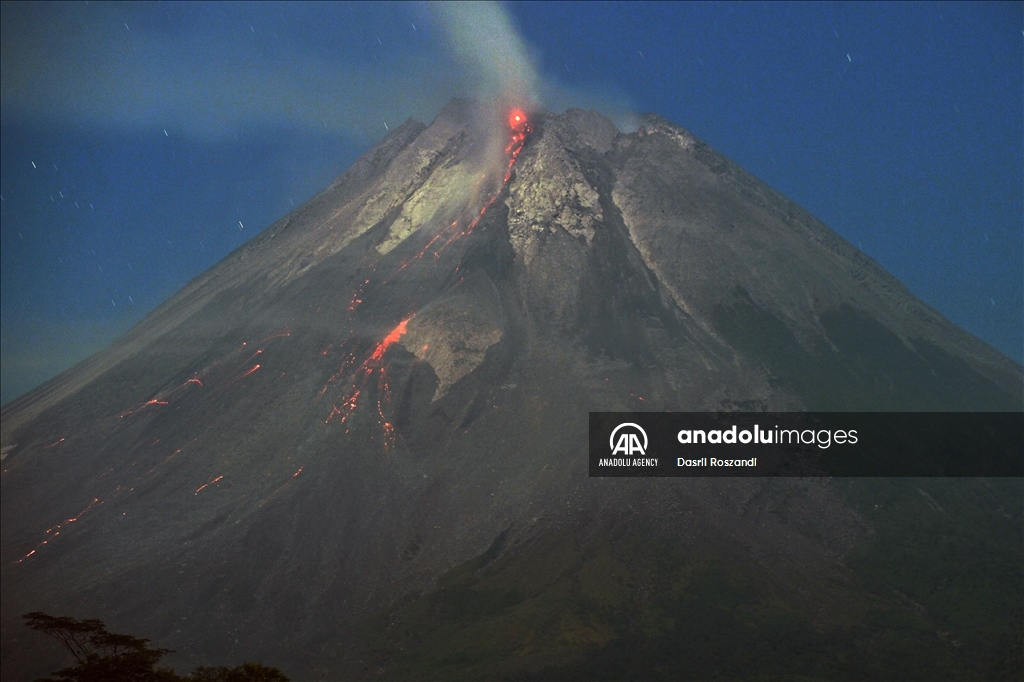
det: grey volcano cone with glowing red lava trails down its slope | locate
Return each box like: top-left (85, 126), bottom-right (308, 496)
top-left (0, 101), bottom-right (1024, 679)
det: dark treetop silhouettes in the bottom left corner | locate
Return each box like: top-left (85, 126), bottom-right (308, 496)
top-left (23, 611), bottom-right (289, 682)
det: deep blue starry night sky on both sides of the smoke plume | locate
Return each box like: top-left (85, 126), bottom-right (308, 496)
top-left (0, 2), bottom-right (1024, 403)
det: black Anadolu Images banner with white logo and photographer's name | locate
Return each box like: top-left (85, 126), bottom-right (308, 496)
top-left (590, 412), bottom-right (1024, 477)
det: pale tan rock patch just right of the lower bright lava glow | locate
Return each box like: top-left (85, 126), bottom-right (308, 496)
top-left (401, 293), bottom-right (502, 400)
